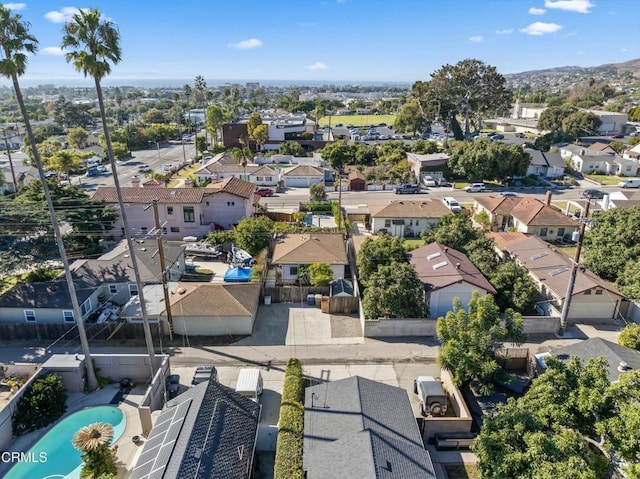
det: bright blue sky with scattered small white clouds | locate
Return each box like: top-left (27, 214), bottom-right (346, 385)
top-left (2, 0), bottom-right (640, 85)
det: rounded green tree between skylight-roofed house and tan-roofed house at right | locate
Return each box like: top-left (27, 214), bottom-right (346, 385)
top-left (489, 261), bottom-right (538, 314)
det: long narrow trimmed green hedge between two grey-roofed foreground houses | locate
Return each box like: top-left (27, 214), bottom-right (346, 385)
top-left (274, 358), bottom-right (304, 479)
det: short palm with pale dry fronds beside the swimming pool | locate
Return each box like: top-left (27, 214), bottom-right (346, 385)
top-left (72, 422), bottom-right (118, 477)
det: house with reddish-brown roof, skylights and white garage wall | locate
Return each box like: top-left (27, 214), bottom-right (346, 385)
top-left (407, 243), bottom-right (496, 318)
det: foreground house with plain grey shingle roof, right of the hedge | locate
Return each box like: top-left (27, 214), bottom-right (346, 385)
top-left (303, 376), bottom-right (436, 479)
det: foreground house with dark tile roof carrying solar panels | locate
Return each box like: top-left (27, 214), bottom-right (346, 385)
top-left (130, 380), bottom-right (261, 479)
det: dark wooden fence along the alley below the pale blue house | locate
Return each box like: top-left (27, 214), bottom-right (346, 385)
top-left (0, 321), bottom-right (158, 343)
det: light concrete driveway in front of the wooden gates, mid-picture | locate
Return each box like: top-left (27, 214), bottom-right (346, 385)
top-left (235, 303), bottom-right (364, 346)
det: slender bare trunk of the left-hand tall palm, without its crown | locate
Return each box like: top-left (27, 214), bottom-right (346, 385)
top-left (11, 74), bottom-right (99, 391)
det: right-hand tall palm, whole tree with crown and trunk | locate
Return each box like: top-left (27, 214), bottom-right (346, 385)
top-left (62, 8), bottom-right (158, 366)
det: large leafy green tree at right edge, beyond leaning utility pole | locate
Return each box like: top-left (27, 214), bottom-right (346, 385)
top-left (583, 206), bottom-right (640, 284)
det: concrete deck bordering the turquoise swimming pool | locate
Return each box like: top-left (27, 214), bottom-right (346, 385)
top-left (0, 386), bottom-right (146, 479)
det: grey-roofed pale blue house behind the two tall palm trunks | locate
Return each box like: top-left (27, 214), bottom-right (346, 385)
top-left (0, 241), bottom-right (185, 324)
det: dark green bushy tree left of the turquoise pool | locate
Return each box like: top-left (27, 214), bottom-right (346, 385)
top-left (12, 374), bottom-right (67, 436)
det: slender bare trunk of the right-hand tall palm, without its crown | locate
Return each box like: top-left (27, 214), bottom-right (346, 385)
top-left (94, 77), bottom-right (156, 377)
